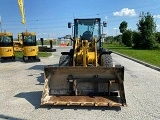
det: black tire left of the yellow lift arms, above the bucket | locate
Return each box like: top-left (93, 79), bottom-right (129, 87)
top-left (59, 55), bottom-right (71, 66)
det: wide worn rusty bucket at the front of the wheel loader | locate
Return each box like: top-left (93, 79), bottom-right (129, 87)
top-left (41, 66), bottom-right (126, 106)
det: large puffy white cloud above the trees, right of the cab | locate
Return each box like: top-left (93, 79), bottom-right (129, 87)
top-left (113, 8), bottom-right (136, 16)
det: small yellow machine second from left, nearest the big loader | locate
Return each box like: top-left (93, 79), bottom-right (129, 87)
top-left (21, 31), bottom-right (40, 62)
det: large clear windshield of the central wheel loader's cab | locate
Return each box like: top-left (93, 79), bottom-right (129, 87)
top-left (74, 19), bottom-right (100, 39)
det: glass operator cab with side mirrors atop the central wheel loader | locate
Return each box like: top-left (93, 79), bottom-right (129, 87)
top-left (66, 18), bottom-right (107, 50)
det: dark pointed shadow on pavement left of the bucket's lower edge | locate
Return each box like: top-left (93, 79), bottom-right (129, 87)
top-left (14, 91), bottom-right (42, 109)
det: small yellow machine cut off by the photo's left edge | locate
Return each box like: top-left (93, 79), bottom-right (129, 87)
top-left (0, 31), bottom-right (15, 62)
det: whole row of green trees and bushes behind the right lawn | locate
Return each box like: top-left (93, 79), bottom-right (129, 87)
top-left (105, 12), bottom-right (160, 50)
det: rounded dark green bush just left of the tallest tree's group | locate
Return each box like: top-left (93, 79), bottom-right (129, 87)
top-left (122, 30), bottom-right (133, 47)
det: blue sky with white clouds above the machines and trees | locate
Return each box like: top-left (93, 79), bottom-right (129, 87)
top-left (0, 0), bottom-right (160, 38)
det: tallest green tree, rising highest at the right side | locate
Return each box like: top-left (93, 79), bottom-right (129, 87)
top-left (137, 12), bottom-right (156, 49)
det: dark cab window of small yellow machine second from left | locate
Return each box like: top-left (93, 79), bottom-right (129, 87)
top-left (23, 36), bottom-right (36, 46)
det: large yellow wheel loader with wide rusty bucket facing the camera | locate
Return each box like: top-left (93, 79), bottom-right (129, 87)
top-left (41, 18), bottom-right (126, 106)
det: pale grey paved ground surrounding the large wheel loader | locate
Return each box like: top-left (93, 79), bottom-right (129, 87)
top-left (0, 47), bottom-right (160, 120)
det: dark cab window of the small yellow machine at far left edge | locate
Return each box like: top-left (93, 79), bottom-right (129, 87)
top-left (0, 36), bottom-right (13, 46)
